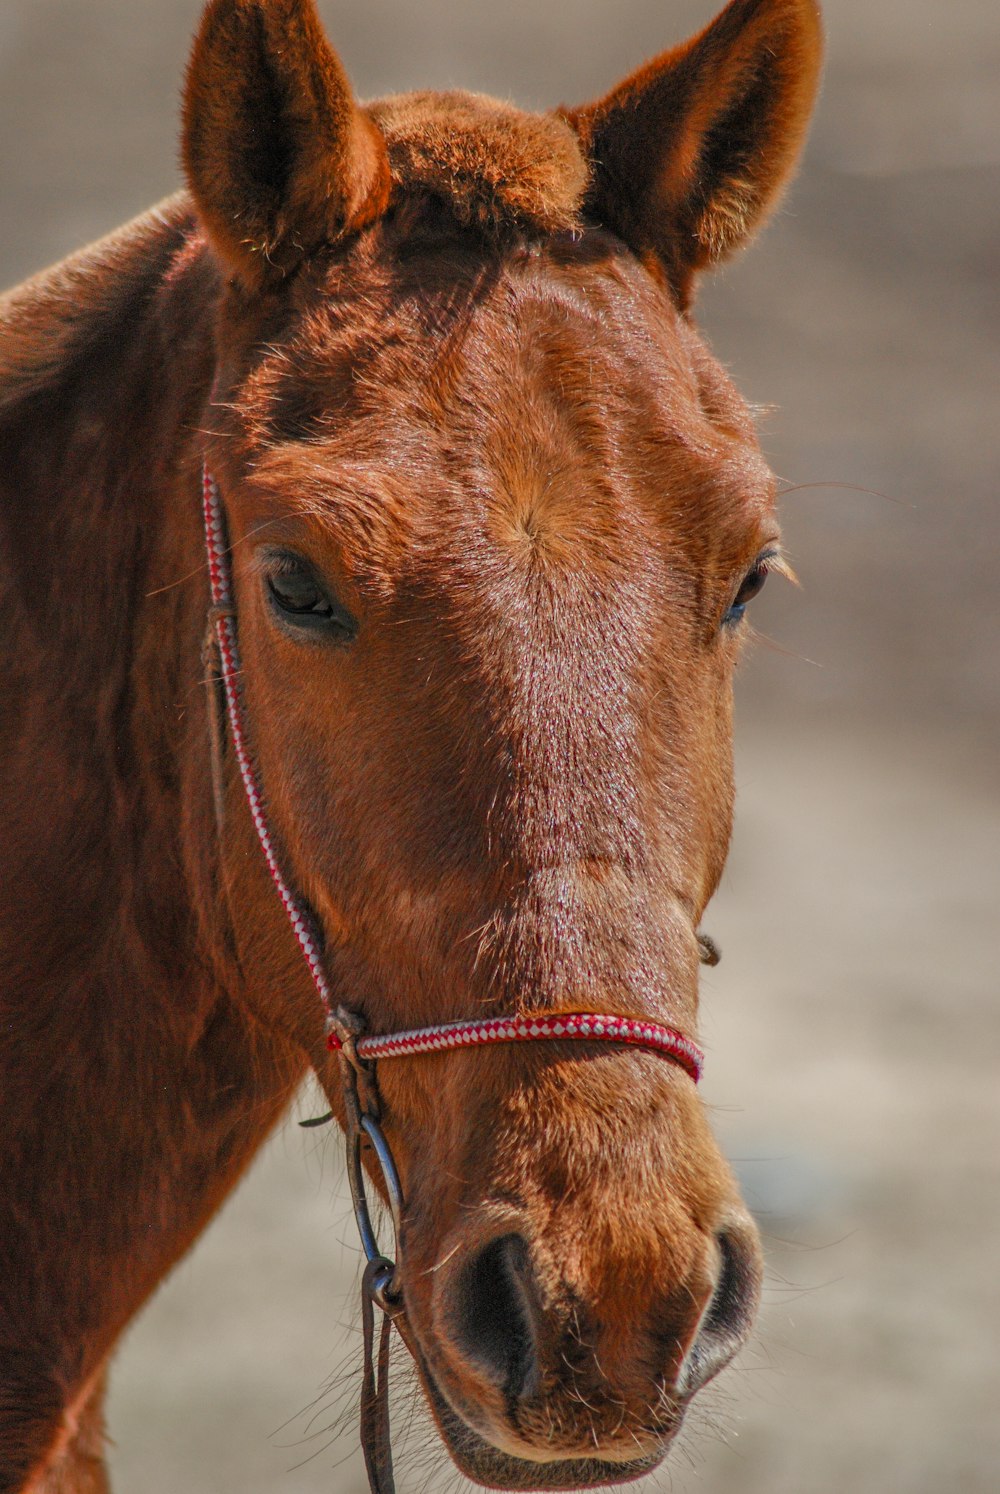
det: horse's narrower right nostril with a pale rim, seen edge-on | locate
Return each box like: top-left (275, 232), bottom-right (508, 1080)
top-left (674, 1212), bottom-right (761, 1400)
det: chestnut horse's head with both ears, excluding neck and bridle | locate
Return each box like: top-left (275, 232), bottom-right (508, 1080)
top-left (184, 0), bottom-right (821, 1488)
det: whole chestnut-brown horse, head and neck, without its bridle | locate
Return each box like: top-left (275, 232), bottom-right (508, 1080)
top-left (0, 0), bottom-right (821, 1494)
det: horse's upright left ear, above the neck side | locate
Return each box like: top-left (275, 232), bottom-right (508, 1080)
top-left (184, 0), bottom-right (389, 290)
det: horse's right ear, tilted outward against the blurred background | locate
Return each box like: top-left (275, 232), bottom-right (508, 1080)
top-left (561, 0), bottom-right (822, 305)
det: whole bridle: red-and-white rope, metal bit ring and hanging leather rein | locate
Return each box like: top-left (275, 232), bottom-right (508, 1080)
top-left (202, 463), bottom-right (708, 1494)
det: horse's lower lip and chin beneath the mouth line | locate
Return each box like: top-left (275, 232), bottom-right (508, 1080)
top-left (413, 1346), bottom-right (676, 1491)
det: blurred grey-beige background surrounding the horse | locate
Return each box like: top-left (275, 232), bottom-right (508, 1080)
top-left (0, 0), bottom-right (1000, 1494)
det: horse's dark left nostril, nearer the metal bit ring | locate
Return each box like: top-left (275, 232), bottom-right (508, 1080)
top-left (453, 1234), bottom-right (538, 1400)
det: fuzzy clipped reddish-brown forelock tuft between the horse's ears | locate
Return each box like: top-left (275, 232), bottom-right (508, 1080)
top-left (368, 93), bottom-right (589, 236)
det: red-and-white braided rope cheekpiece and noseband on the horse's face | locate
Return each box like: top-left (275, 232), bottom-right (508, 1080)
top-left (202, 463), bottom-right (704, 1083)
